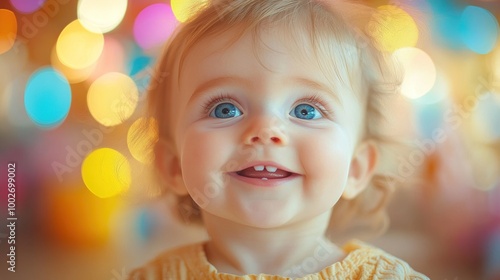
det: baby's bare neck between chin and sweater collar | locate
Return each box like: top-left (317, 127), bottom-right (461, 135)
top-left (203, 212), bottom-right (344, 277)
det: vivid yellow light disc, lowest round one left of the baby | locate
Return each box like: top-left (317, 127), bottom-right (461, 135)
top-left (82, 148), bottom-right (131, 198)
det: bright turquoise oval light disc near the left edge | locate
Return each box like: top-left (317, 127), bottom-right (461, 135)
top-left (24, 67), bottom-right (71, 128)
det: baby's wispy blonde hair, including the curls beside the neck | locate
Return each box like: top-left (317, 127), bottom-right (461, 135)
top-left (144, 0), bottom-right (400, 241)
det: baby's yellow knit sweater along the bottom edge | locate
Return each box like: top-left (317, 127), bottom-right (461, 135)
top-left (129, 241), bottom-right (429, 280)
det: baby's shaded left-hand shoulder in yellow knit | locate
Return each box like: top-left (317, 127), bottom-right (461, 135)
top-left (128, 243), bottom-right (206, 280)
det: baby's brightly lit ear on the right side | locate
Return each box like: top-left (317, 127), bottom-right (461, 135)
top-left (342, 140), bottom-right (378, 199)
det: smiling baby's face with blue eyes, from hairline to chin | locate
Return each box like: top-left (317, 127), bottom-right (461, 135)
top-left (172, 25), bottom-right (364, 228)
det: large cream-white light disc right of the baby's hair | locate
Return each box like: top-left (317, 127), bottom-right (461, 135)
top-left (394, 48), bottom-right (437, 99)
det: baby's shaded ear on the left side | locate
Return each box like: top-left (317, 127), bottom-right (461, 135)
top-left (155, 139), bottom-right (188, 195)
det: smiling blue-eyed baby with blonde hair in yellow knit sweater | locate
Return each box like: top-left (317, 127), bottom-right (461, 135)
top-left (130, 0), bottom-right (428, 279)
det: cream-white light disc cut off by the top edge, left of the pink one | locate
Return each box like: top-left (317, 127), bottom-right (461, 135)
top-left (77, 0), bottom-right (127, 33)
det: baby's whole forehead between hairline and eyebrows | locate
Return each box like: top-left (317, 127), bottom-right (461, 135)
top-left (178, 25), bottom-right (361, 99)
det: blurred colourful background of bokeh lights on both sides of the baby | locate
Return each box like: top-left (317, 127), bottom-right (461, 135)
top-left (0, 0), bottom-right (500, 280)
